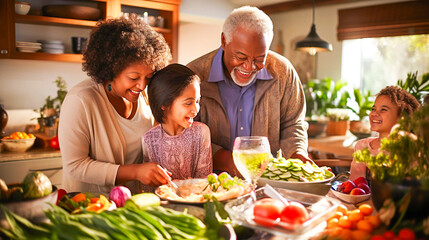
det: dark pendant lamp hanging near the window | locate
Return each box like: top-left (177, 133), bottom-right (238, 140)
top-left (295, 0), bottom-right (332, 55)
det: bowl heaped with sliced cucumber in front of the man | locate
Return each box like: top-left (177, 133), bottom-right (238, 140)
top-left (258, 156), bottom-right (335, 195)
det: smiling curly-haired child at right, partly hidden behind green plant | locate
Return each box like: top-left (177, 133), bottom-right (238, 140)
top-left (350, 86), bottom-right (420, 180)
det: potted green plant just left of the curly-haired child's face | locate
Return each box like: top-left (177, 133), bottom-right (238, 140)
top-left (349, 88), bottom-right (374, 138)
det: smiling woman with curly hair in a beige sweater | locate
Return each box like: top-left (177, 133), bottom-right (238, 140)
top-left (58, 17), bottom-right (171, 193)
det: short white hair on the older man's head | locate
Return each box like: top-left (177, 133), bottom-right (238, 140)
top-left (222, 6), bottom-right (274, 47)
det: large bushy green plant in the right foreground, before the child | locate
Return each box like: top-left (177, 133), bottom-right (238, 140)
top-left (353, 105), bottom-right (429, 237)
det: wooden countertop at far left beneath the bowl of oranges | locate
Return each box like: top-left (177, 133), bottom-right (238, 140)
top-left (0, 148), bottom-right (61, 162)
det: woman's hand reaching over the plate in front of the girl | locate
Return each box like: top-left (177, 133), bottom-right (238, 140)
top-left (137, 162), bottom-right (171, 187)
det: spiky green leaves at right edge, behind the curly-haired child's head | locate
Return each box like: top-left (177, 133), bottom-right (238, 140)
top-left (397, 71), bottom-right (429, 103)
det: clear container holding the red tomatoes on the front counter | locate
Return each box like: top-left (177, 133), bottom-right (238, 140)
top-left (225, 188), bottom-right (340, 239)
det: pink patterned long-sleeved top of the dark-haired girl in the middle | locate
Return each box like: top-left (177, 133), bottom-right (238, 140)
top-left (142, 122), bottom-right (213, 179)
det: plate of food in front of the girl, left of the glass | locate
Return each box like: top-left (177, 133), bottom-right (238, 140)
top-left (155, 178), bottom-right (252, 204)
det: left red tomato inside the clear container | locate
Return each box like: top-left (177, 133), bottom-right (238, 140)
top-left (253, 198), bottom-right (284, 227)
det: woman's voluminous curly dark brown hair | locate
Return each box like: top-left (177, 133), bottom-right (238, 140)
top-left (82, 16), bottom-right (171, 84)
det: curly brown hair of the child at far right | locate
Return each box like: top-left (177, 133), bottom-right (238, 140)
top-left (376, 86), bottom-right (420, 116)
